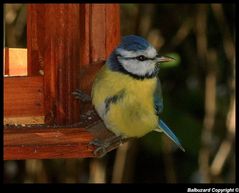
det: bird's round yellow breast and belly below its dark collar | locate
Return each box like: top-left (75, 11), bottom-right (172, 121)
top-left (92, 65), bottom-right (158, 137)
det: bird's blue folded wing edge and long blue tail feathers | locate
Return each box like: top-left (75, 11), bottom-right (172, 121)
top-left (154, 80), bottom-right (185, 151)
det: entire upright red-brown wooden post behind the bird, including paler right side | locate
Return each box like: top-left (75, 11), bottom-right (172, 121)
top-left (28, 4), bottom-right (120, 124)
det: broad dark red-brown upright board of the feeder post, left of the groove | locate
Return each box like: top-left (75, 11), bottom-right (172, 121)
top-left (29, 4), bottom-right (80, 125)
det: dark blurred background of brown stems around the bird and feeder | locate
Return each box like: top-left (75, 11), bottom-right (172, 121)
top-left (4, 4), bottom-right (236, 183)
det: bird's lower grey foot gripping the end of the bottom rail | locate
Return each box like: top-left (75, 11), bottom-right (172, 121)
top-left (90, 136), bottom-right (122, 158)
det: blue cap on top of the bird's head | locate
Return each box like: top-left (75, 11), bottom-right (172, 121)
top-left (118, 35), bottom-right (150, 51)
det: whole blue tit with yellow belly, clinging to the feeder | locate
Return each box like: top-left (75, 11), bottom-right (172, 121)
top-left (91, 35), bottom-right (185, 155)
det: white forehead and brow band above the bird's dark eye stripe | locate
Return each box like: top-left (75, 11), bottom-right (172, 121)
top-left (116, 46), bottom-right (157, 58)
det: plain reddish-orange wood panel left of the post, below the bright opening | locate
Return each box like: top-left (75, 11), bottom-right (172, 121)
top-left (4, 76), bottom-right (44, 117)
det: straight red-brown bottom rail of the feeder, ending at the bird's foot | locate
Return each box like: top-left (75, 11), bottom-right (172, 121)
top-left (4, 128), bottom-right (94, 160)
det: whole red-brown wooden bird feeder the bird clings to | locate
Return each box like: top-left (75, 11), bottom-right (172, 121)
top-left (4, 4), bottom-right (120, 160)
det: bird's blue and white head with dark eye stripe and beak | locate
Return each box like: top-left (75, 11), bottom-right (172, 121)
top-left (107, 35), bottom-right (173, 79)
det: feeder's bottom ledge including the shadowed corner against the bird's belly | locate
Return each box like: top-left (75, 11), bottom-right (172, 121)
top-left (4, 111), bottom-right (119, 160)
